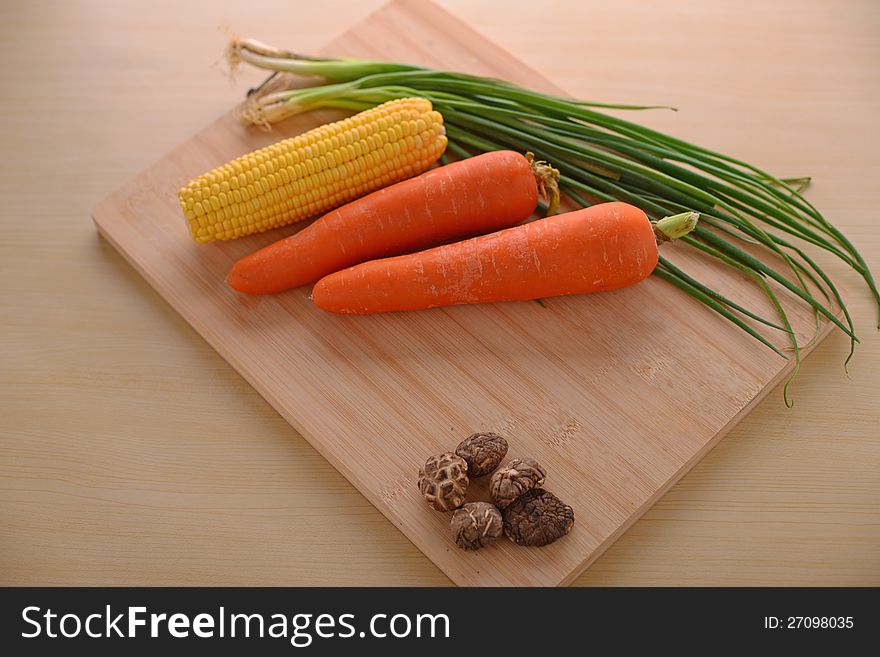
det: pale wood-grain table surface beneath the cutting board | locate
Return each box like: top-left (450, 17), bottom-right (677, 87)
top-left (0, 0), bottom-right (880, 585)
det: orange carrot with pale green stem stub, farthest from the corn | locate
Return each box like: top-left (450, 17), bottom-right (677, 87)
top-left (312, 202), bottom-right (699, 314)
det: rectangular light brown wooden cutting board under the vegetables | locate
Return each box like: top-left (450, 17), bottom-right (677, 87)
top-left (93, 0), bottom-right (828, 585)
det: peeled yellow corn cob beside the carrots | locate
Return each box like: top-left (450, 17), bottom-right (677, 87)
top-left (179, 98), bottom-right (446, 242)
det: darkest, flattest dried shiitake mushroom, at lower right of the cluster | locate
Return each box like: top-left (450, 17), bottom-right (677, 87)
top-left (504, 488), bottom-right (574, 547)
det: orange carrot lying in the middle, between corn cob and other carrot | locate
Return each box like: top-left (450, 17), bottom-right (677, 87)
top-left (227, 151), bottom-right (559, 294)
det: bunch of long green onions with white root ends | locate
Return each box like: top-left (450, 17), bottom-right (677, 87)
top-left (227, 39), bottom-right (880, 404)
